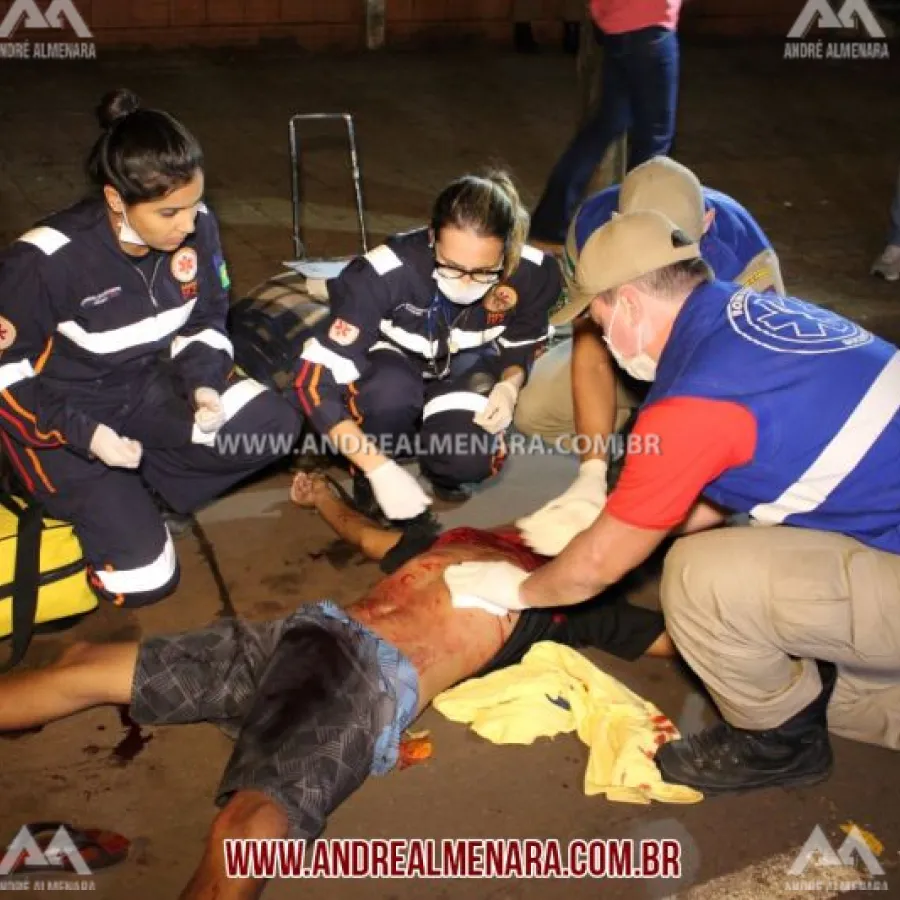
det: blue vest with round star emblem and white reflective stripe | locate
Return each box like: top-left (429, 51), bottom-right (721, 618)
top-left (646, 282), bottom-right (900, 553)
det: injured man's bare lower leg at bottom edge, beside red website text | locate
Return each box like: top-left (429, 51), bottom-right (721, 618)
top-left (179, 791), bottom-right (288, 900)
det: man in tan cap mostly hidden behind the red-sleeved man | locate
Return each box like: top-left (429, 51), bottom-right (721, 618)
top-left (515, 156), bottom-right (784, 556)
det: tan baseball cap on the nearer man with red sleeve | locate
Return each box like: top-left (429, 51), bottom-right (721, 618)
top-left (550, 209), bottom-right (700, 325)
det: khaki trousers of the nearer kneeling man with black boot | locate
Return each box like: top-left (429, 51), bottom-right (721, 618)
top-left (662, 526), bottom-right (900, 750)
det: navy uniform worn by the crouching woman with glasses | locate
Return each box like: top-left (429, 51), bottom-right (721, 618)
top-left (295, 228), bottom-right (561, 487)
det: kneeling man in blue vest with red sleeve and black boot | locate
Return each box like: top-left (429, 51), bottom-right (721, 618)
top-left (444, 210), bottom-right (900, 794)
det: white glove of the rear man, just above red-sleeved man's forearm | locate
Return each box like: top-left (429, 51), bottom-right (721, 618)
top-left (516, 459), bottom-right (607, 556)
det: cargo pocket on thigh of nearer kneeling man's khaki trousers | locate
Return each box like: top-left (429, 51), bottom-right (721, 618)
top-left (769, 548), bottom-right (853, 661)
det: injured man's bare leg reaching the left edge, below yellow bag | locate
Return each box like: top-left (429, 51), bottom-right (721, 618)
top-left (0, 642), bottom-right (138, 731)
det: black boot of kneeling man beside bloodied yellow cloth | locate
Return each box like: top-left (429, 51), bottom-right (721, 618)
top-left (656, 666), bottom-right (836, 796)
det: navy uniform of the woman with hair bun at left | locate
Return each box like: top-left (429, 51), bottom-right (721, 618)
top-left (0, 200), bottom-right (298, 605)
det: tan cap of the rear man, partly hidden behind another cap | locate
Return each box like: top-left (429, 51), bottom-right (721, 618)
top-left (619, 156), bottom-right (705, 241)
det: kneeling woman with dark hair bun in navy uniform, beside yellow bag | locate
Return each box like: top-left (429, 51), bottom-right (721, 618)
top-left (0, 90), bottom-right (299, 606)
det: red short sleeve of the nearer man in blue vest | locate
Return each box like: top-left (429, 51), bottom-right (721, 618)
top-left (606, 397), bottom-right (756, 531)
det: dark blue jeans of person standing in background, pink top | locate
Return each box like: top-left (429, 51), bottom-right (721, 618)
top-left (531, 27), bottom-right (678, 243)
